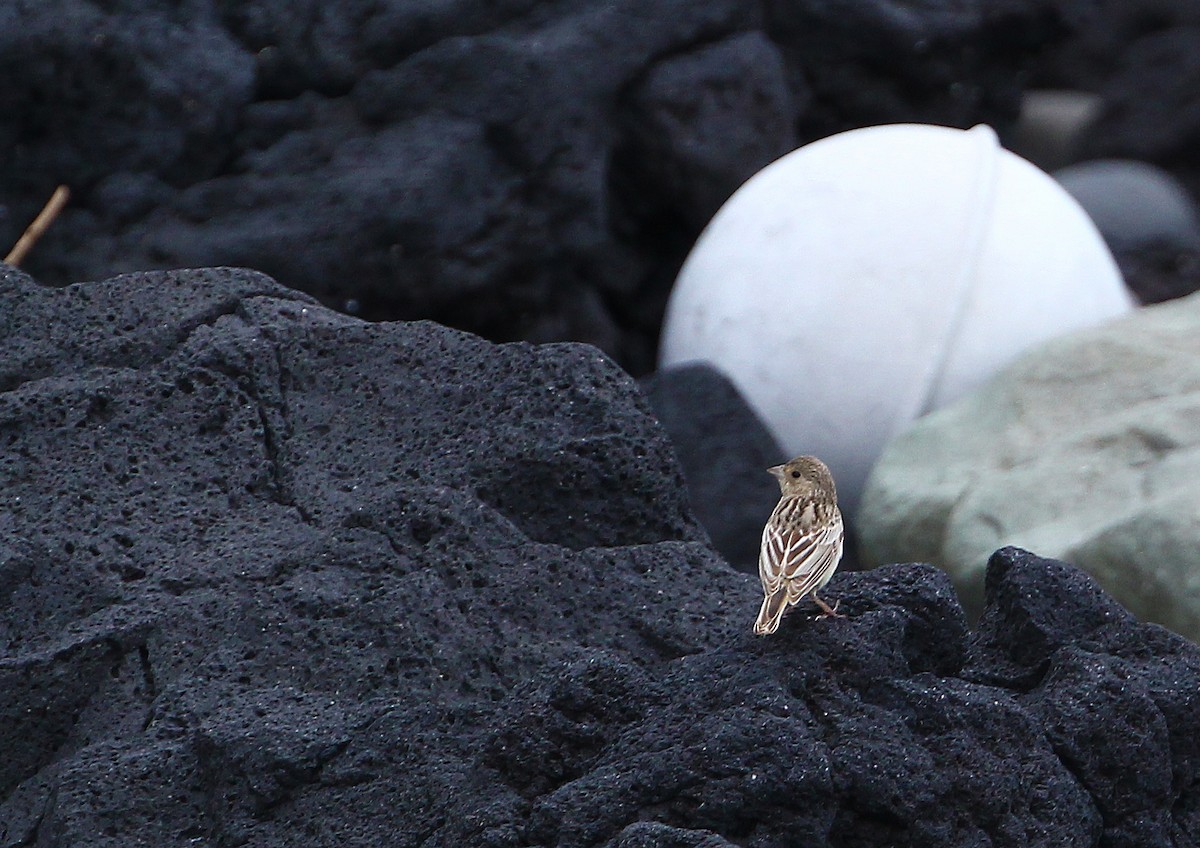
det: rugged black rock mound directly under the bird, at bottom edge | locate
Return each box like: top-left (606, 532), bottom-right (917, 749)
top-left (492, 566), bottom-right (1099, 846)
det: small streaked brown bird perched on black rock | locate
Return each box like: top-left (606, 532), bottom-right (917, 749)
top-left (754, 457), bottom-right (845, 636)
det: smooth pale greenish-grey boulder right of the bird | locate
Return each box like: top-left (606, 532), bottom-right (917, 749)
top-left (859, 295), bottom-right (1200, 638)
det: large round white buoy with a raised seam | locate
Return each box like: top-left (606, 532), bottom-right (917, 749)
top-left (660, 125), bottom-right (1134, 510)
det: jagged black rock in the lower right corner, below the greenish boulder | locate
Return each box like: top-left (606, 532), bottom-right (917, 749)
top-left (965, 548), bottom-right (1200, 846)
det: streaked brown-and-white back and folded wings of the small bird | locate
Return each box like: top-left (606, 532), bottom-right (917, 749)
top-left (758, 512), bottom-right (844, 603)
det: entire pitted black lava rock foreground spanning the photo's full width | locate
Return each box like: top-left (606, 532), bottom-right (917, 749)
top-left (0, 270), bottom-right (1200, 848)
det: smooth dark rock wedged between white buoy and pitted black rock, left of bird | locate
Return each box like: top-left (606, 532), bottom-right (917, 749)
top-left (642, 363), bottom-right (791, 573)
